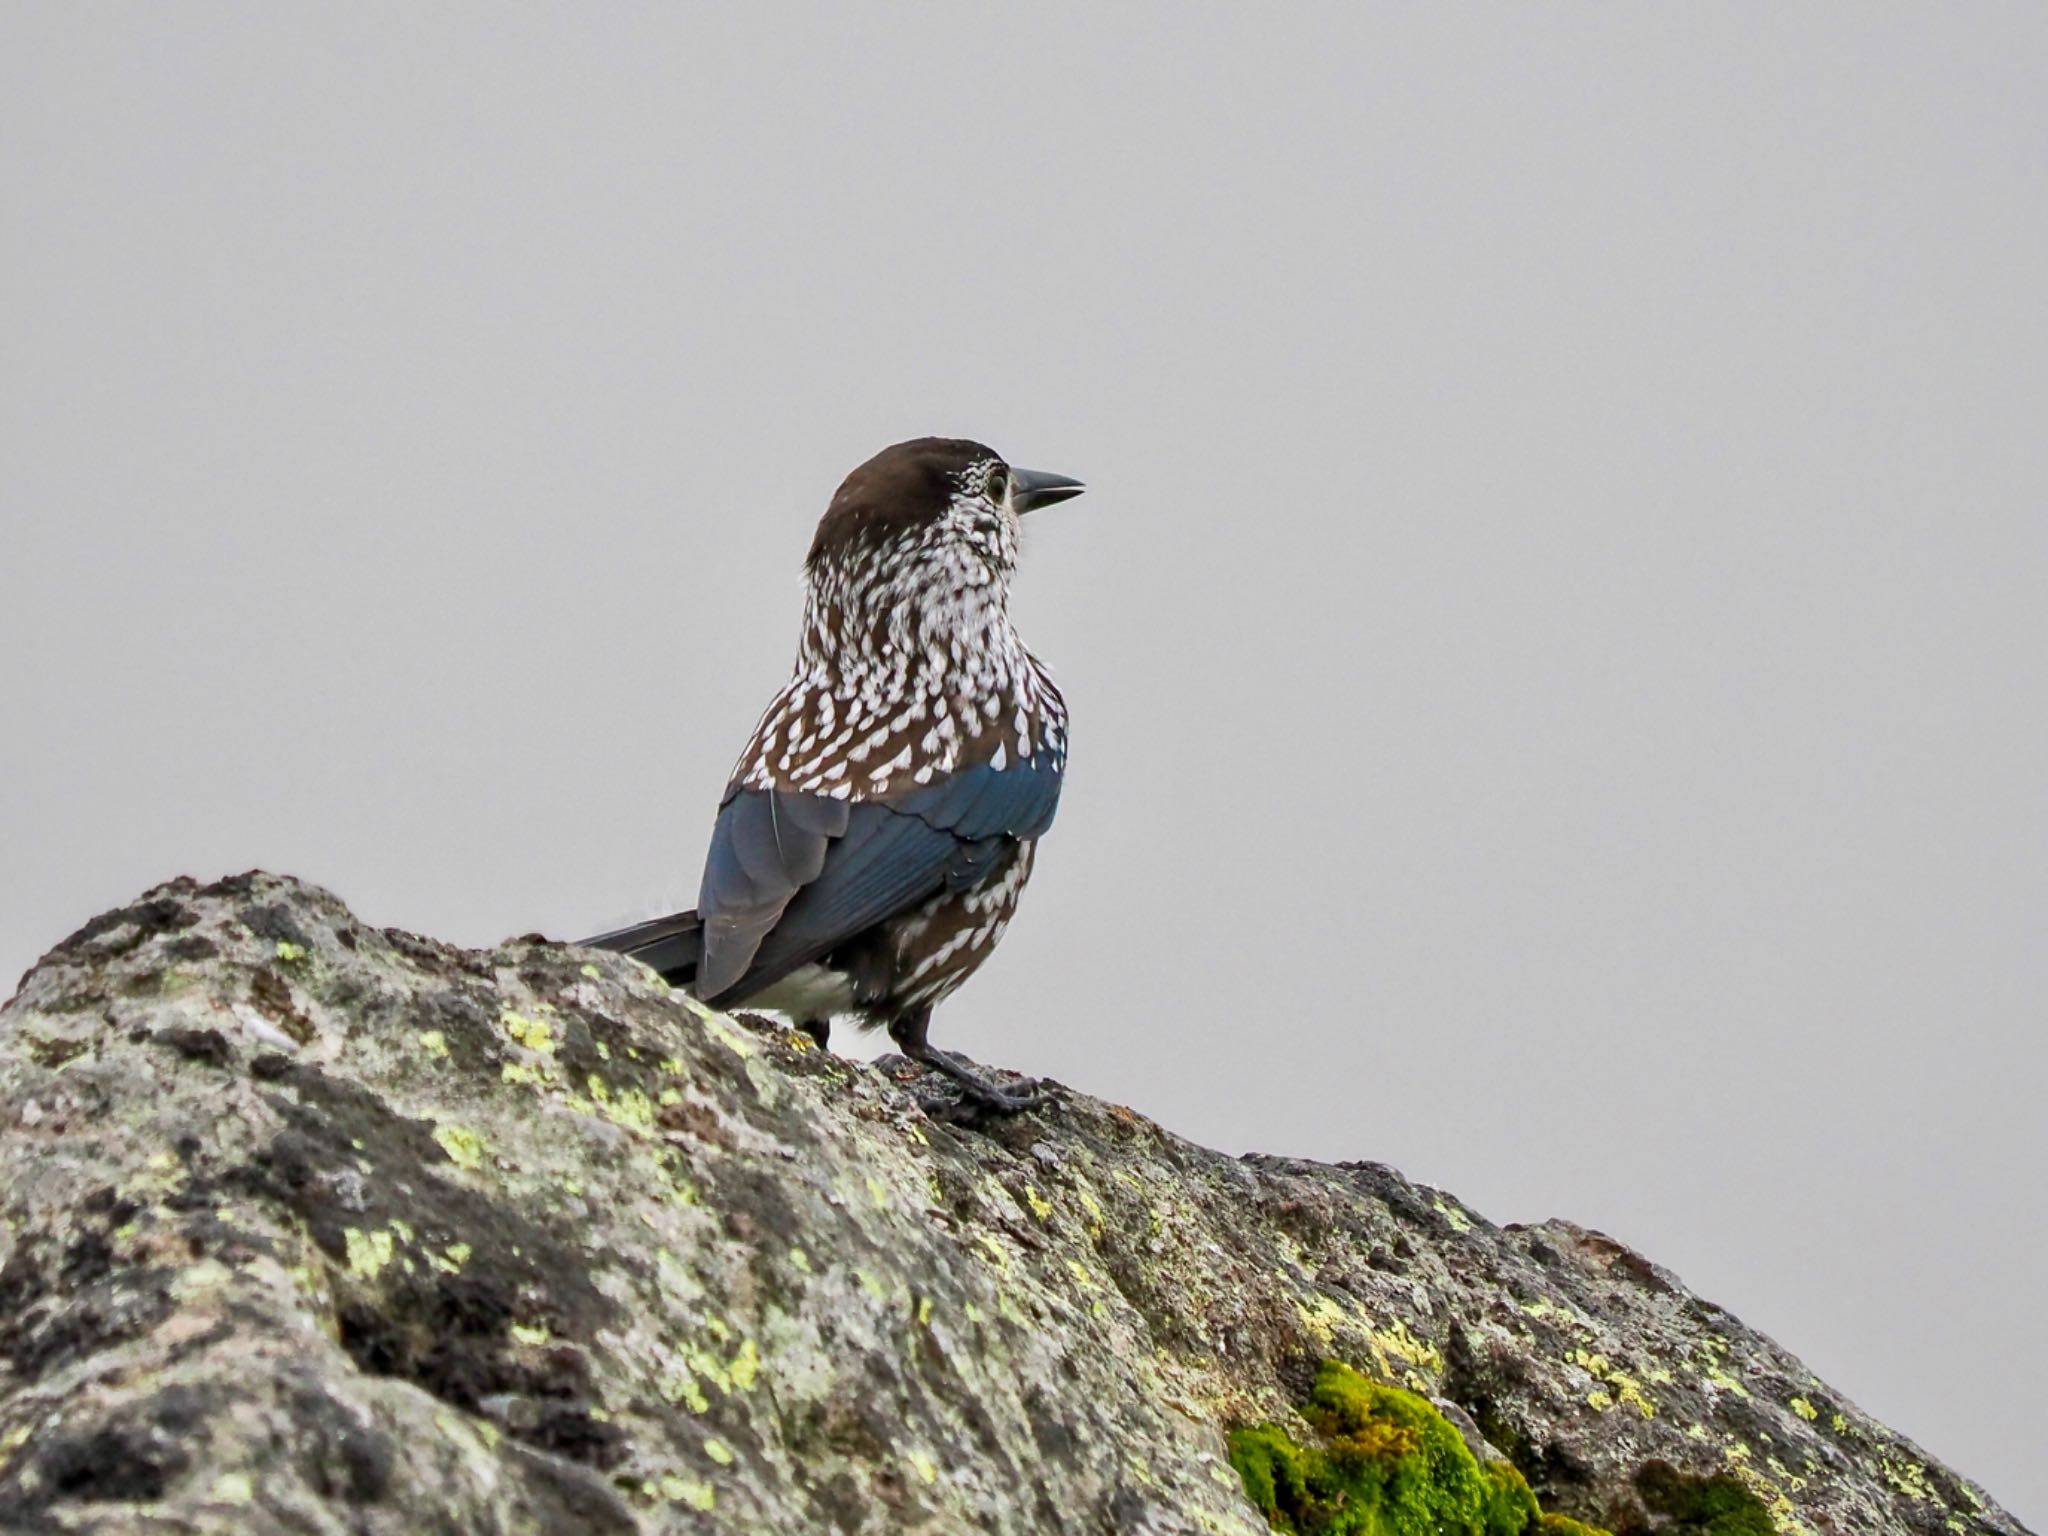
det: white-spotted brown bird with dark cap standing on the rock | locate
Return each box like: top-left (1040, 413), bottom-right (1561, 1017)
top-left (584, 438), bottom-right (1085, 1114)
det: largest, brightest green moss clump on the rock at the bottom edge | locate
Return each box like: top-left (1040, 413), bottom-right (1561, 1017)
top-left (1231, 1360), bottom-right (1605, 1536)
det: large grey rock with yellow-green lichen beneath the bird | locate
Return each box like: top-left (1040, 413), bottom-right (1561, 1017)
top-left (0, 874), bottom-right (2019, 1536)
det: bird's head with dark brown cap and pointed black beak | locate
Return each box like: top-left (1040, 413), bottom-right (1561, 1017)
top-left (805, 438), bottom-right (1081, 596)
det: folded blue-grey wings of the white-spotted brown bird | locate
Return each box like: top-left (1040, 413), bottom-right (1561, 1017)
top-left (696, 758), bottom-right (1061, 999)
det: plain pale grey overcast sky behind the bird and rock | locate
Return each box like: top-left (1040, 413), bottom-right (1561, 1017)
top-left (0, 2), bottom-right (2048, 1524)
